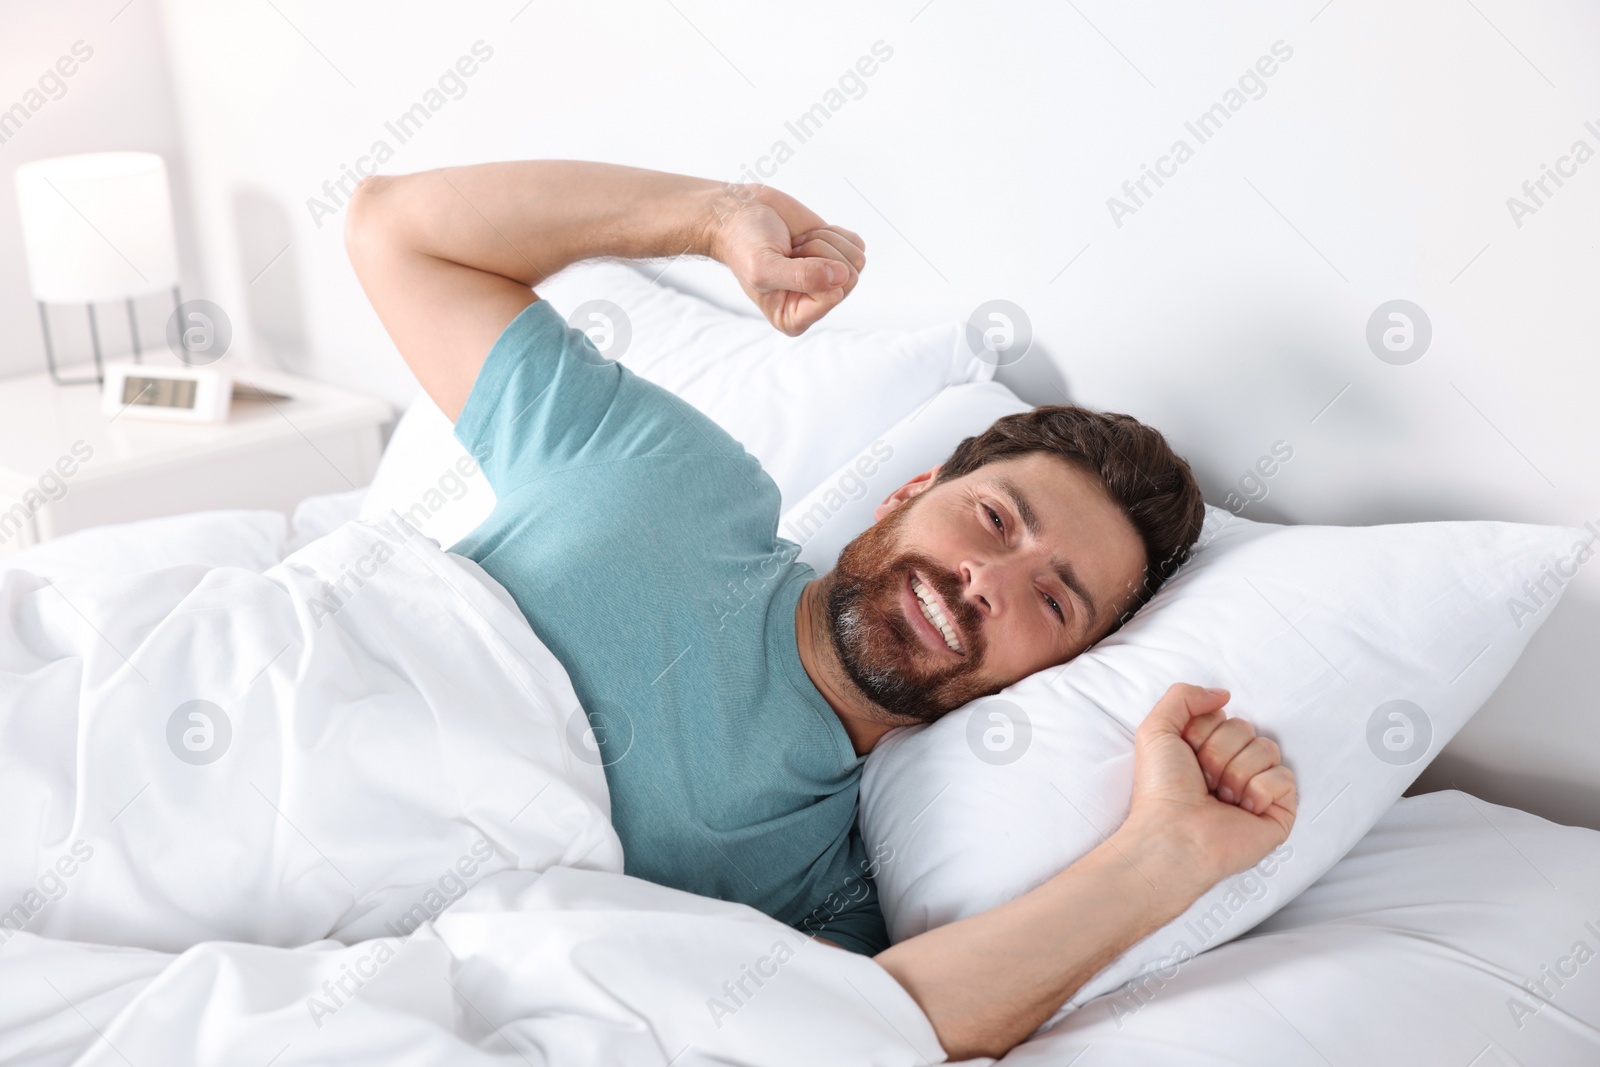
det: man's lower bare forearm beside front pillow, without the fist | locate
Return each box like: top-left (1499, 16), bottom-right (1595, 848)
top-left (877, 835), bottom-right (1205, 1059)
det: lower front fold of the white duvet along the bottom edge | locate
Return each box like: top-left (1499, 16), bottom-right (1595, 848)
top-left (0, 867), bottom-right (944, 1067)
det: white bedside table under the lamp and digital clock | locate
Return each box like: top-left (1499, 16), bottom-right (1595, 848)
top-left (0, 370), bottom-right (394, 557)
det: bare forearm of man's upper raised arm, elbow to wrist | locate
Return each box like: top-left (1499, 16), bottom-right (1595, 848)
top-left (358, 160), bottom-right (722, 286)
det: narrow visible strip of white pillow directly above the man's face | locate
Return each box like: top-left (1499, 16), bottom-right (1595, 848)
top-left (778, 381), bottom-right (1032, 574)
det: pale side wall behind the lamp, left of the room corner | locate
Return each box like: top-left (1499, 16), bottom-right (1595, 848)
top-left (0, 0), bottom-right (205, 378)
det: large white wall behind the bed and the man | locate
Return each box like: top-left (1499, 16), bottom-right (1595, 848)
top-left (59, 0), bottom-right (1600, 825)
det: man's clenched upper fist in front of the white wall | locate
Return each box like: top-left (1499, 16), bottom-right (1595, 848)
top-left (706, 186), bottom-right (867, 338)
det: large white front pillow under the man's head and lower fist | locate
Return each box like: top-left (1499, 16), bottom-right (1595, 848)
top-left (861, 507), bottom-right (1592, 1011)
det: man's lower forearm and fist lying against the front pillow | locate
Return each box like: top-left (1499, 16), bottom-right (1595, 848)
top-left (875, 685), bottom-right (1296, 1059)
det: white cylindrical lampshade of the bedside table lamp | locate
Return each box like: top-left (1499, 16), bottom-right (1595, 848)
top-left (16, 152), bottom-right (178, 304)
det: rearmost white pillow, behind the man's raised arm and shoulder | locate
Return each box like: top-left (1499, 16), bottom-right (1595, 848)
top-left (362, 261), bottom-right (995, 547)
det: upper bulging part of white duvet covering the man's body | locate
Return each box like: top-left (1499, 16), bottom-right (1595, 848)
top-left (0, 522), bottom-right (622, 950)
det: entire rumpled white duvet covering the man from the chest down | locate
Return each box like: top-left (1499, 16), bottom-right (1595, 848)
top-left (0, 518), bottom-right (939, 1067)
